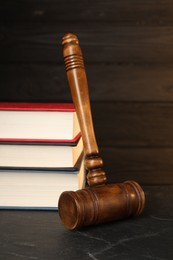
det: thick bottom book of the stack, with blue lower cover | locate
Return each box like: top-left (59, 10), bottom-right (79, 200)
top-left (0, 160), bottom-right (85, 210)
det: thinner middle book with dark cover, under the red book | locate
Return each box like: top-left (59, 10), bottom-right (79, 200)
top-left (0, 136), bottom-right (83, 169)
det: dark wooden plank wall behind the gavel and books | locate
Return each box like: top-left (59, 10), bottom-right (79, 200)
top-left (0, 0), bottom-right (173, 184)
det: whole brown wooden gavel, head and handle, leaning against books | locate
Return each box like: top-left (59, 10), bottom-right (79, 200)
top-left (58, 33), bottom-right (145, 230)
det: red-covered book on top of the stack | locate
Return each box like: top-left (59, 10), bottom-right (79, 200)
top-left (0, 102), bottom-right (80, 143)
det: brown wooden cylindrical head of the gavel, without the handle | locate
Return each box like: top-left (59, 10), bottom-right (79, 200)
top-left (58, 181), bottom-right (145, 230)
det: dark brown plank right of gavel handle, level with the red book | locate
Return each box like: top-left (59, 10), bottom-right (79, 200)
top-left (92, 102), bottom-right (173, 147)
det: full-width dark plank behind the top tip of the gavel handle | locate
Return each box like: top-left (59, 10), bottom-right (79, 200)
top-left (0, 23), bottom-right (173, 64)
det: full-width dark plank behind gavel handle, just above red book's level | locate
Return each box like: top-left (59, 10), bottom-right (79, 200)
top-left (0, 62), bottom-right (173, 102)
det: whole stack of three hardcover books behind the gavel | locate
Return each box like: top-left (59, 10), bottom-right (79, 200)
top-left (0, 102), bottom-right (85, 209)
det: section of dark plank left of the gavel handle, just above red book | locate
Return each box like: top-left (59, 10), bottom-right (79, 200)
top-left (0, 63), bottom-right (71, 102)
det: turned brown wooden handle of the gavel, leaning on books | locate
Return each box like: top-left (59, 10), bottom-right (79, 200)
top-left (62, 33), bottom-right (107, 186)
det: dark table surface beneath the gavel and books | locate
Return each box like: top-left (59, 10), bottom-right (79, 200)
top-left (0, 186), bottom-right (173, 260)
